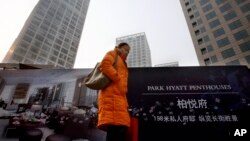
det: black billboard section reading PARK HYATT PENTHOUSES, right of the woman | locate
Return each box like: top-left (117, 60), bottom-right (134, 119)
top-left (128, 66), bottom-right (250, 141)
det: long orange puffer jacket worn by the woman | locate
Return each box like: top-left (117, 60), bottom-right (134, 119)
top-left (97, 49), bottom-right (130, 130)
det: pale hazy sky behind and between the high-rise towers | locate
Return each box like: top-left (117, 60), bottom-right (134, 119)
top-left (0, 0), bottom-right (199, 68)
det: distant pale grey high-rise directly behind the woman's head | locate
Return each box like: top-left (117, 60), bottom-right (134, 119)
top-left (116, 32), bottom-right (152, 67)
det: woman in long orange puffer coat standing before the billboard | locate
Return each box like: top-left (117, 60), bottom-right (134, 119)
top-left (97, 43), bottom-right (130, 141)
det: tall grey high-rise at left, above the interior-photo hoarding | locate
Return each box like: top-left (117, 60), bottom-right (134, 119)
top-left (3, 0), bottom-right (90, 68)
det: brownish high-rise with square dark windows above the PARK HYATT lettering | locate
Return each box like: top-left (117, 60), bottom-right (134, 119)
top-left (180, 0), bottom-right (250, 67)
